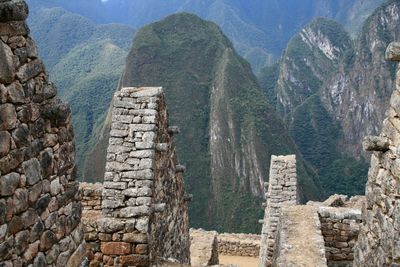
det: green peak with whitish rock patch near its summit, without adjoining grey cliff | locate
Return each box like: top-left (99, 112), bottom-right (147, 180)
top-left (266, 18), bottom-right (366, 194)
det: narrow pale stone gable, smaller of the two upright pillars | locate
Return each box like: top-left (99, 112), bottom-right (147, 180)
top-left (259, 155), bottom-right (298, 267)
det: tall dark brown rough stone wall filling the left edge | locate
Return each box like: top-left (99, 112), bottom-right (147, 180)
top-left (0, 0), bottom-right (85, 267)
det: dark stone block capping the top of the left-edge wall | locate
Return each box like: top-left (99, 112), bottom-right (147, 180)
top-left (0, 0), bottom-right (28, 22)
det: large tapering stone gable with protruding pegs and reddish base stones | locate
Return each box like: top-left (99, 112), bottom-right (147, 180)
top-left (81, 87), bottom-right (190, 266)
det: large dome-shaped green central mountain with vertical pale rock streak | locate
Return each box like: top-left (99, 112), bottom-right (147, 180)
top-left (88, 13), bottom-right (321, 232)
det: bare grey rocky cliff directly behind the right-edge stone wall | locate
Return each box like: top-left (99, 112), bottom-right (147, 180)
top-left (321, 1), bottom-right (400, 157)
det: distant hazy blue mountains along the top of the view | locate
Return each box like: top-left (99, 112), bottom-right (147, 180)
top-left (28, 0), bottom-right (384, 71)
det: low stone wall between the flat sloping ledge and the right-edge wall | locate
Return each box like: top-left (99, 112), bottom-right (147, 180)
top-left (318, 207), bottom-right (361, 266)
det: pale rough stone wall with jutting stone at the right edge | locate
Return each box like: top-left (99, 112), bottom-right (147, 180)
top-left (354, 43), bottom-right (400, 267)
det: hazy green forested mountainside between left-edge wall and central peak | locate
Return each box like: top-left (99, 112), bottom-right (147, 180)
top-left (29, 8), bottom-right (134, 177)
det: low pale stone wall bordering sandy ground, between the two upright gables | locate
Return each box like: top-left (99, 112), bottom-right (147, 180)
top-left (217, 233), bottom-right (261, 257)
